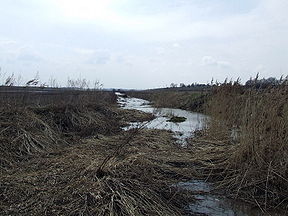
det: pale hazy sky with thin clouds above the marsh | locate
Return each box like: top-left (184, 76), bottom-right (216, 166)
top-left (0, 0), bottom-right (288, 89)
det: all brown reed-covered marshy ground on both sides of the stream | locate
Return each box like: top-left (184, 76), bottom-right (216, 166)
top-left (0, 84), bottom-right (288, 216)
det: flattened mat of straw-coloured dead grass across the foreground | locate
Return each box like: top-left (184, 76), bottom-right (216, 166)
top-left (0, 130), bottom-right (196, 216)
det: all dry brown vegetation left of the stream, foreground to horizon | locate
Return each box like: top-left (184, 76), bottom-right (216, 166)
top-left (0, 87), bottom-right (196, 216)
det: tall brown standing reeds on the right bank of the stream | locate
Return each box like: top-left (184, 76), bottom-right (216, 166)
top-left (192, 82), bottom-right (288, 211)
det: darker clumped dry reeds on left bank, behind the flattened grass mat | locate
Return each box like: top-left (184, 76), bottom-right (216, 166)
top-left (0, 90), bottom-right (120, 170)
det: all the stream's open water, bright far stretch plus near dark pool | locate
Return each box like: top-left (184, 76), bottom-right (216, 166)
top-left (116, 93), bottom-right (286, 216)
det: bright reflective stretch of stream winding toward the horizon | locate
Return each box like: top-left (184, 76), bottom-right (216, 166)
top-left (117, 93), bottom-right (207, 146)
